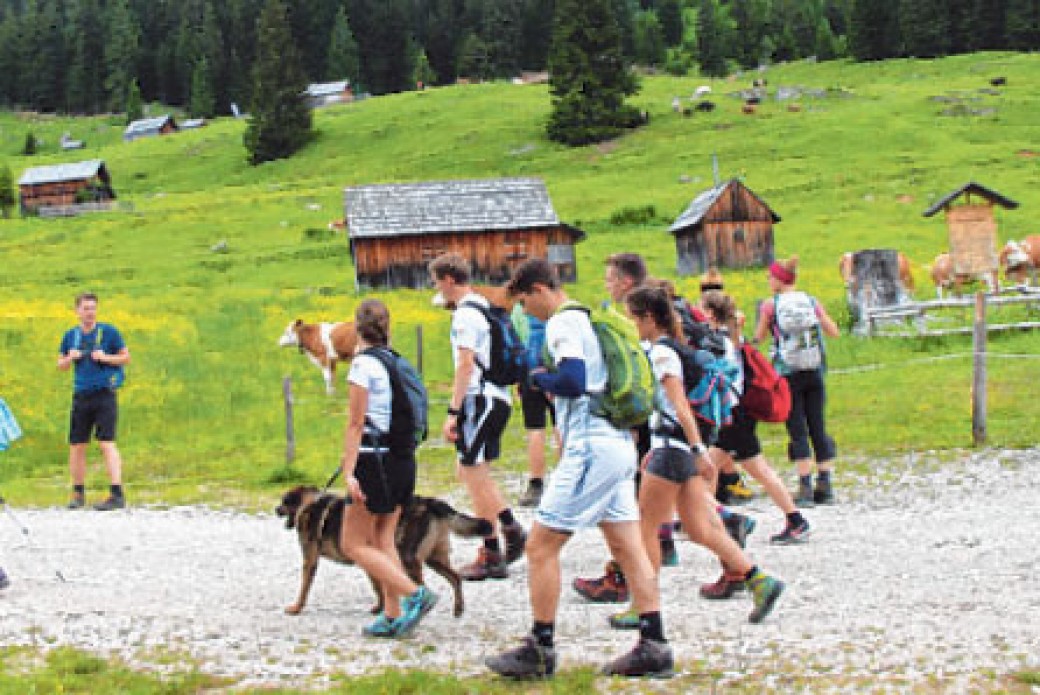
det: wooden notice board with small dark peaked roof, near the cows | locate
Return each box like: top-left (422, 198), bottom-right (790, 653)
top-left (922, 181), bottom-right (1018, 290)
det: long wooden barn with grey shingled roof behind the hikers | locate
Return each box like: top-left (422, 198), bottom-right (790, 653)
top-left (344, 178), bottom-right (584, 289)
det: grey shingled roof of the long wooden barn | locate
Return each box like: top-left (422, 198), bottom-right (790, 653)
top-left (344, 178), bottom-right (584, 238)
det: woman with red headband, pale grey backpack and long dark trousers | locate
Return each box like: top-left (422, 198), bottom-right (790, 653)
top-left (754, 256), bottom-right (841, 508)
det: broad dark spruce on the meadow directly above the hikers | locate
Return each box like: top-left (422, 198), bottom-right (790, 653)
top-left (546, 0), bottom-right (640, 146)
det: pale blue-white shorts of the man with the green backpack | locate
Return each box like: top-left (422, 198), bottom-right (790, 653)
top-left (535, 437), bottom-right (640, 533)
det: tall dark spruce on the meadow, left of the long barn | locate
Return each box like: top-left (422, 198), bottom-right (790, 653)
top-left (243, 0), bottom-right (311, 164)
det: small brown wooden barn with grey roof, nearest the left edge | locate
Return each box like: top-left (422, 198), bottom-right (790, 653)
top-left (18, 159), bottom-right (115, 214)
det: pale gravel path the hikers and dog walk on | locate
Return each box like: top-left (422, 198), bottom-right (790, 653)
top-left (0, 449), bottom-right (1040, 690)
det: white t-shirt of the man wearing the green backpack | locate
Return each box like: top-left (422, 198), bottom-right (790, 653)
top-left (545, 309), bottom-right (629, 442)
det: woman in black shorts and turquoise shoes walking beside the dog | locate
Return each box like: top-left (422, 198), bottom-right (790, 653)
top-left (339, 300), bottom-right (437, 638)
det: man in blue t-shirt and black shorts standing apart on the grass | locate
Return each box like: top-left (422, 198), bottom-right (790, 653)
top-left (57, 292), bottom-right (130, 511)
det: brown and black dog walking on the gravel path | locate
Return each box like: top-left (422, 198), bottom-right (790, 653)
top-left (275, 485), bottom-right (491, 618)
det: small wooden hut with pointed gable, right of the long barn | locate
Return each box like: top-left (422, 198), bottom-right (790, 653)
top-left (669, 179), bottom-right (780, 275)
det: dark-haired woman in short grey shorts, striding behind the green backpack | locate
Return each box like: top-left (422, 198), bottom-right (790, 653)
top-left (610, 287), bottom-right (784, 629)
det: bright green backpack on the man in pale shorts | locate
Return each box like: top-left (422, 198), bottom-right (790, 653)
top-left (556, 302), bottom-right (654, 430)
